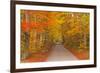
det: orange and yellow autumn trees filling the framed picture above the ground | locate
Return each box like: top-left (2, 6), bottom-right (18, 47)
top-left (20, 10), bottom-right (90, 61)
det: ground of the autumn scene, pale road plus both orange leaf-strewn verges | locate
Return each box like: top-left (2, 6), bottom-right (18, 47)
top-left (23, 45), bottom-right (89, 62)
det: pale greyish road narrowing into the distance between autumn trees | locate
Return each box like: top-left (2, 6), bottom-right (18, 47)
top-left (47, 45), bottom-right (77, 61)
